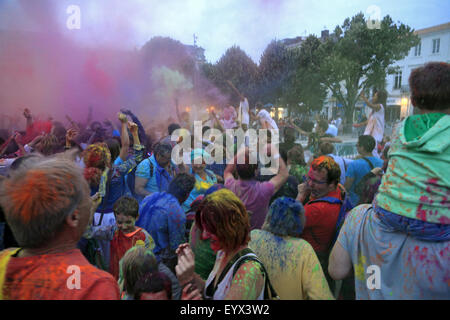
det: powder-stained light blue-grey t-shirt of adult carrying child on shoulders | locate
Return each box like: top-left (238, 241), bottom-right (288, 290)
top-left (337, 204), bottom-right (450, 300)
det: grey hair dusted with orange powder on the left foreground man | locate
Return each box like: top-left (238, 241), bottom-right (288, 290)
top-left (0, 158), bottom-right (89, 248)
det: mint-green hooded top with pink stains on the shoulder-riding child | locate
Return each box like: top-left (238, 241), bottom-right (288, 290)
top-left (376, 114), bottom-right (450, 224)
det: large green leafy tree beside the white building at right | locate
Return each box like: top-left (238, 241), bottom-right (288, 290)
top-left (312, 13), bottom-right (419, 121)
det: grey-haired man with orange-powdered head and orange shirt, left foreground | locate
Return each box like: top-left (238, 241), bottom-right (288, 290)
top-left (0, 158), bottom-right (119, 300)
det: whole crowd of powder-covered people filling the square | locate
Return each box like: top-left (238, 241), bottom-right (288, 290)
top-left (0, 63), bottom-right (450, 300)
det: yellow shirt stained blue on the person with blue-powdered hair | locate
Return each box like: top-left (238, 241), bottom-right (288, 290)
top-left (249, 230), bottom-right (334, 300)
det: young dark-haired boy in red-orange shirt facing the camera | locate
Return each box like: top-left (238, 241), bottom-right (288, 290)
top-left (88, 196), bottom-right (155, 280)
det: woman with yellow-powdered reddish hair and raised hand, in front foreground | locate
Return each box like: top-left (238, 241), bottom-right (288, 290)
top-left (176, 189), bottom-right (267, 300)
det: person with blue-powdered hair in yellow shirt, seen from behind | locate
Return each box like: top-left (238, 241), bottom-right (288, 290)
top-left (249, 197), bottom-right (334, 300)
